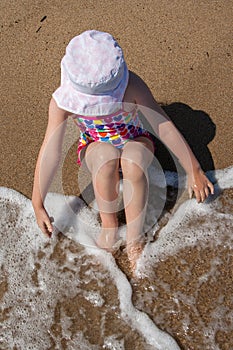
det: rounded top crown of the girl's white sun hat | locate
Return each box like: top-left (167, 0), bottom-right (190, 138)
top-left (62, 30), bottom-right (125, 93)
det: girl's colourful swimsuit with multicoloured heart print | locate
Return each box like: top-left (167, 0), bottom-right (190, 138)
top-left (73, 108), bottom-right (151, 164)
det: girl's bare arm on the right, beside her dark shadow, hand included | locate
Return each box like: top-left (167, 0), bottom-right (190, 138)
top-left (130, 74), bottom-right (214, 202)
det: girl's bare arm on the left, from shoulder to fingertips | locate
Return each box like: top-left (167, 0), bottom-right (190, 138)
top-left (32, 98), bottom-right (68, 237)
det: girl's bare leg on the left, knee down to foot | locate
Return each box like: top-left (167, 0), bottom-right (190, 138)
top-left (85, 142), bottom-right (120, 251)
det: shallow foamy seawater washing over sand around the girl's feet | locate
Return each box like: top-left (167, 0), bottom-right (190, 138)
top-left (0, 168), bottom-right (233, 350)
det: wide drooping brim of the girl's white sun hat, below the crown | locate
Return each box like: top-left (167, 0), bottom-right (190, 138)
top-left (52, 60), bottom-right (129, 116)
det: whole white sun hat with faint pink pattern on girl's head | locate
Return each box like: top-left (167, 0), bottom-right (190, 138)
top-left (53, 30), bottom-right (129, 116)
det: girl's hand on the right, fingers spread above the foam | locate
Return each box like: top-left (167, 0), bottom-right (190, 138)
top-left (188, 168), bottom-right (214, 203)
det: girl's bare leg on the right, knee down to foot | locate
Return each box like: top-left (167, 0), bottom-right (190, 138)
top-left (121, 137), bottom-right (154, 268)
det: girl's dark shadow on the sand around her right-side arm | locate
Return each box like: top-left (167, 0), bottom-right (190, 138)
top-left (141, 102), bottom-right (216, 228)
